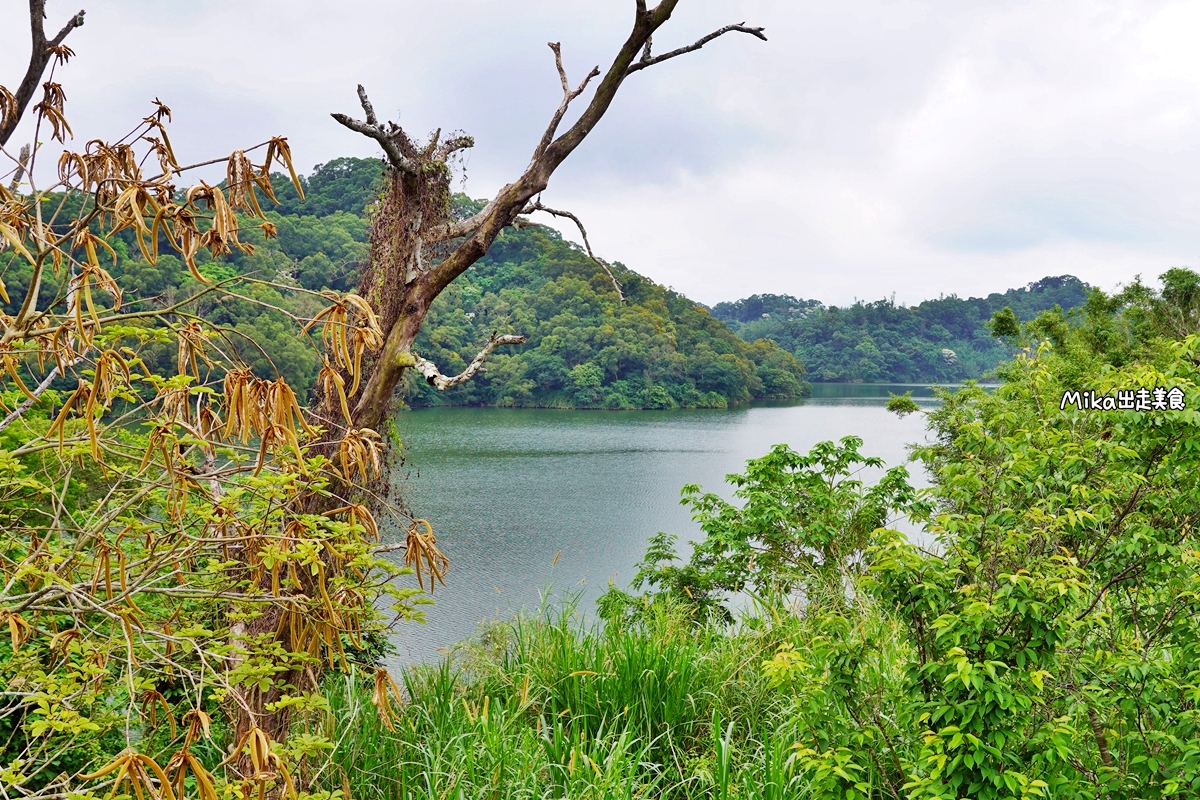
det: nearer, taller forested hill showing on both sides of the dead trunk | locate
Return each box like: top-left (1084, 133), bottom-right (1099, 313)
top-left (0, 158), bottom-right (809, 408)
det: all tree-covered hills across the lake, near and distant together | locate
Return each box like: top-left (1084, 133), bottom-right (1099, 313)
top-left (7, 158), bottom-right (1104, 409)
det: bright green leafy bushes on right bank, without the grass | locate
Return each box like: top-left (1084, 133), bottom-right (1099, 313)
top-left (590, 270), bottom-right (1200, 799)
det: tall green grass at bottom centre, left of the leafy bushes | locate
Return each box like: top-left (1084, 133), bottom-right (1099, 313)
top-left (312, 603), bottom-right (883, 800)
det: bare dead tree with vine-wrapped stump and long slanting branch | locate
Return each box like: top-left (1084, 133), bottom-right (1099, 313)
top-left (320, 0), bottom-right (767, 429)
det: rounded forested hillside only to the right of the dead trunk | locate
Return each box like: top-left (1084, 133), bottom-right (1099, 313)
top-left (406, 225), bottom-right (808, 409)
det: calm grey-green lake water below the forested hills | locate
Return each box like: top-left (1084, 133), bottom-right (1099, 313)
top-left (384, 384), bottom-right (935, 667)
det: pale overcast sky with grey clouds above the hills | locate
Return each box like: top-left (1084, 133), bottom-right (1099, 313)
top-left (0, 0), bottom-right (1200, 303)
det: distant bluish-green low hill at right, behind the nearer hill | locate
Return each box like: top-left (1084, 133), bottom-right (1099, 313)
top-left (713, 275), bottom-right (1090, 384)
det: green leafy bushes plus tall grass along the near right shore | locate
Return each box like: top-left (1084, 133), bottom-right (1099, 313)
top-left (218, 270), bottom-right (1200, 800)
